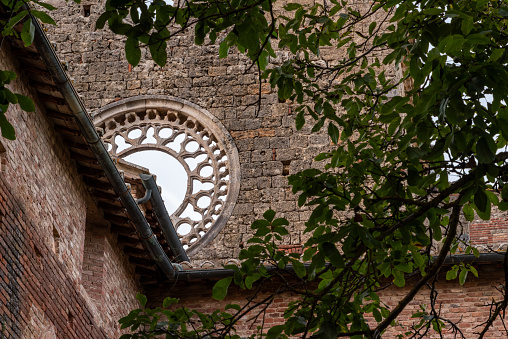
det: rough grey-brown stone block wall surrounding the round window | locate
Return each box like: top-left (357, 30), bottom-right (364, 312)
top-left (48, 2), bottom-right (348, 267)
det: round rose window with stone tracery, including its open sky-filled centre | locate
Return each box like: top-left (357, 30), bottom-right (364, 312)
top-left (94, 96), bottom-right (240, 255)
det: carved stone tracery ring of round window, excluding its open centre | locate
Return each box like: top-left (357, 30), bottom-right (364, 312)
top-left (93, 95), bottom-right (241, 256)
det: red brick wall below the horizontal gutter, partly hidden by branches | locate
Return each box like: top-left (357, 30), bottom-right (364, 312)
top-left (149, 264), bottom-right (506, 338)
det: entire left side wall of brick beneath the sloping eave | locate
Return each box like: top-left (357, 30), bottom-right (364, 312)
top-left (0, 37), bottom-right (140, 338)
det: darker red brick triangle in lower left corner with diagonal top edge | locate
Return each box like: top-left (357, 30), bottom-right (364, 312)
top-left (0, 177), bottom-right (106, 338)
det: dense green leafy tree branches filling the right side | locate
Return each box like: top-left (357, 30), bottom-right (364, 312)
top-left (97, 0), bottom-right (508, 338)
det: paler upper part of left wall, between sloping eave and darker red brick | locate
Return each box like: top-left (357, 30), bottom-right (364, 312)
top-left (0, 44), bottom-right (88, 282)
